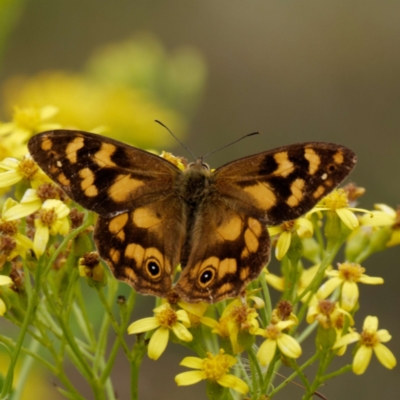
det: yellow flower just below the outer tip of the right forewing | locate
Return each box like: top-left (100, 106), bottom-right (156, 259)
top-left (308, 189), bottom-right (370, 230)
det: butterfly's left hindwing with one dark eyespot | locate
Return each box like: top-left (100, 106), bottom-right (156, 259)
top-left (94, 195), bottom-right (185, 297)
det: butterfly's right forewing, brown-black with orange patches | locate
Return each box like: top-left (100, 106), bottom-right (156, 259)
top-left (215, 143), bottom-right (356, 225)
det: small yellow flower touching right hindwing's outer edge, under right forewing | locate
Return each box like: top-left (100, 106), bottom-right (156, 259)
top-left (268, 218), bottom-right (314, 260)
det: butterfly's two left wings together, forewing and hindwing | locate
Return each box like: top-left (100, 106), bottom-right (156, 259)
top-left (28, 130), bottom-right (186, 297)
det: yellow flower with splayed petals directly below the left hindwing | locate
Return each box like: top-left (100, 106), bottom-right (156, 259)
top-left (128, 303), bottom-right (193, 360)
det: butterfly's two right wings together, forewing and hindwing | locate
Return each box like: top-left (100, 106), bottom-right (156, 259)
top-left (175, 143), bottom-right (356, 302)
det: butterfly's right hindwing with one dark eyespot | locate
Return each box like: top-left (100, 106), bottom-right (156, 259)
top-left (175, 196), bottom-right (270, 303)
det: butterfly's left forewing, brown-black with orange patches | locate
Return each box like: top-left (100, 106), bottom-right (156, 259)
top-left (28, 130), bottom-right (179, 216)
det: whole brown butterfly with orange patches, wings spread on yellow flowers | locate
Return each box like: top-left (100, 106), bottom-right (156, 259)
top-left (28, 130), bottom-right (356, 303)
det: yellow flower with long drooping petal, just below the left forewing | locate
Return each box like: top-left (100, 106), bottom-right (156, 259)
top-left (33, 199), bottom-right (70, 257)
